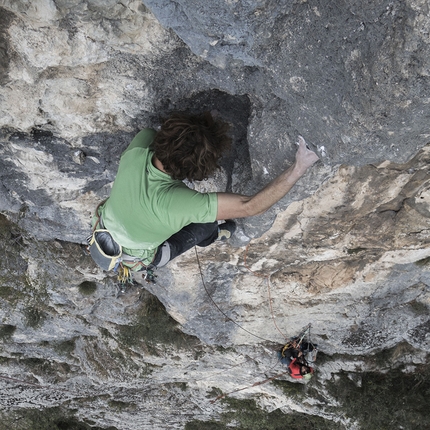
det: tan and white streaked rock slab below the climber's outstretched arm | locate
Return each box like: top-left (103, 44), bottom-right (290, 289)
top-left (152, 146), bottom-right (430, 354)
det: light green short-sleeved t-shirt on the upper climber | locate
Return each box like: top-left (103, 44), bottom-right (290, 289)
top-left (101, 129), bottom-right (218, 264)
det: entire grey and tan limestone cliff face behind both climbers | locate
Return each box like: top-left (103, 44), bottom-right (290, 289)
top-left (0, 0), bottom-right (430, 430)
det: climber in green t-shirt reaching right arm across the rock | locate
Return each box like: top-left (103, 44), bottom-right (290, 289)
top-left (93, 112), bottom-right (318, 269)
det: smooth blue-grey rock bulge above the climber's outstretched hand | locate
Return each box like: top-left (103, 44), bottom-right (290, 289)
top-left (145, 0), bottom-right (430, 164)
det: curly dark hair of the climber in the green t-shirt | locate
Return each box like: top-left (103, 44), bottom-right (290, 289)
top-left (154, 112), bottom-right (231, 181)
